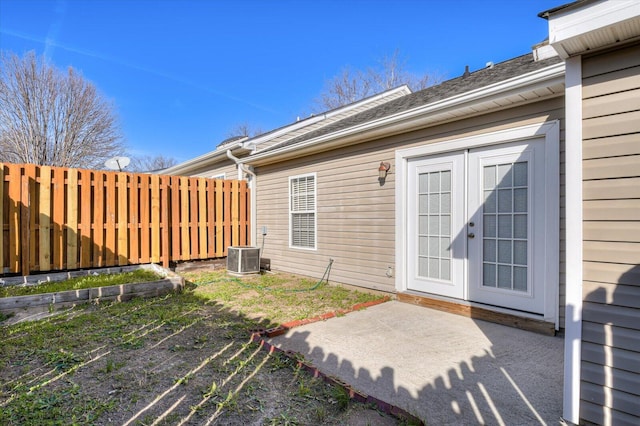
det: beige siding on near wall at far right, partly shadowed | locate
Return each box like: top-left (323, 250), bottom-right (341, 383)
top-left (580, 44), bottom-right (640, 424)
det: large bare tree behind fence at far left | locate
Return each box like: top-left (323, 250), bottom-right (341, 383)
top-left (0, 52), bottom-right (124, 168)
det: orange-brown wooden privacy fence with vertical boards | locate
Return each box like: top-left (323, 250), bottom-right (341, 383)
top-left (0, 163), bottom-right (250, 275)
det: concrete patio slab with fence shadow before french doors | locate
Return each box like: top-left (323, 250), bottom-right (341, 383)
top-left (269, 301), bottom-right (563, 425)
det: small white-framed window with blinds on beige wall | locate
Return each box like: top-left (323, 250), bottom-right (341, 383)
top-left (289, 173), bottom-right (316, 249)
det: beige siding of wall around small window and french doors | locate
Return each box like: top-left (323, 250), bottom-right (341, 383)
top-left (256, 98), bottom-right (565, 312)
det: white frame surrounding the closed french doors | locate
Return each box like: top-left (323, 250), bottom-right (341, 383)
top-left (395, 120), bottom-right (560, 329)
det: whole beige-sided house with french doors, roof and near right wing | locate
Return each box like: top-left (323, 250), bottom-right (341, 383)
top-left (165, 0), bottom-right (640, 424)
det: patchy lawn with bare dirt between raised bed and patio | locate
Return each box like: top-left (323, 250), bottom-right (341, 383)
top-left (0, 272), bottom-right (398, 425)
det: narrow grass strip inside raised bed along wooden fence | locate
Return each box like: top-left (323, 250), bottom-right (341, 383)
top-left (0, 269), bottom-right (163, 297)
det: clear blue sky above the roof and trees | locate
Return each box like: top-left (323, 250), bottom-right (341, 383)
top-left (0, 0), bottom-right (566, 162)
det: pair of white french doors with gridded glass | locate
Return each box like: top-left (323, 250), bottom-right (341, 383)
top-left (407, 139), bottom-right (547, 314)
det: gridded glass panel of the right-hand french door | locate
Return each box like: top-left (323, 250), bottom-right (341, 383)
top-left (482, 161), bottom-right (529, 292)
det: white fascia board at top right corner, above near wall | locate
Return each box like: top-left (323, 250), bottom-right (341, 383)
top-left (548, 0), bottom-right (640, 58)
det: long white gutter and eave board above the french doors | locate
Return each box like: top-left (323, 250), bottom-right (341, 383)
top-left (245, 62), bottom-right (565, 165)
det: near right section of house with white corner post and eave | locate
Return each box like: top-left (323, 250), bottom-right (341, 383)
top-left (541, 1), bottom-right (640, 425)
